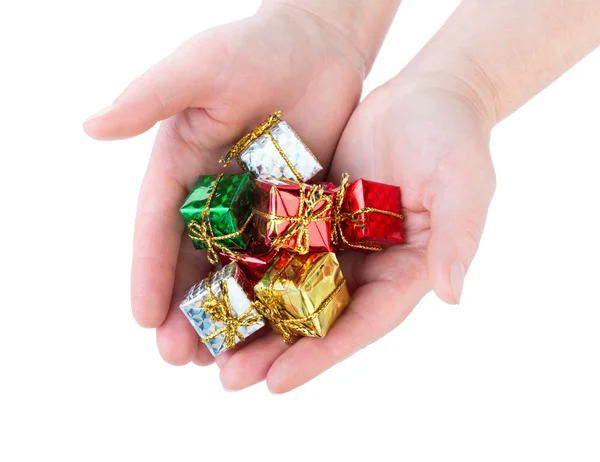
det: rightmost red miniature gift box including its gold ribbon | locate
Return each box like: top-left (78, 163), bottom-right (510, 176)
top-left (332, 174), bottom-right (404, 250)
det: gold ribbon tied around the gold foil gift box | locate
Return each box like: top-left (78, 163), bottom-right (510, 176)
top-left (253, 258), bottom-right (346, 345)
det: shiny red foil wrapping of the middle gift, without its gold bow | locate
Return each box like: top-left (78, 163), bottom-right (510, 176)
top-left (253, 182), bottom-right (335, 252)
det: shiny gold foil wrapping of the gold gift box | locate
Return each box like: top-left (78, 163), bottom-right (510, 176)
top-left (254, 252), bottom-right (351, 337)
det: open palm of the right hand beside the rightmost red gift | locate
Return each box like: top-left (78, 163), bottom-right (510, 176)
top-left (331, 84), bottom-right (494, 298)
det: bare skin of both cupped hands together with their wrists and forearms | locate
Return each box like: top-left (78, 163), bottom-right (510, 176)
top-left (84, 0), bottom-right (600, 392)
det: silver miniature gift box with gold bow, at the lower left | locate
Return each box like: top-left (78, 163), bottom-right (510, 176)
top-left (179, 262), bottom-right (265, 356)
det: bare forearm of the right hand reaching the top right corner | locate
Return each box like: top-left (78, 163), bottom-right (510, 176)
top-left (406, 0), bottom-right (600, 124)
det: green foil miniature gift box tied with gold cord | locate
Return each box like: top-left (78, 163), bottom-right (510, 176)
top-left (180, 173), bottom-right (254, 263)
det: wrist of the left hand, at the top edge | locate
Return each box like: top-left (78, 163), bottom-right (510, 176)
top-left (261, 0), bottom-right (400, 77)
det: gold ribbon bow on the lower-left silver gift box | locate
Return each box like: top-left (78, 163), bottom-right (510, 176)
top-left (202, 273), bottom-right (262, 350)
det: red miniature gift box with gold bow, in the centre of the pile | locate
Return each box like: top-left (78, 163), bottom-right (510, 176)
top-left (253, 182), bottom-right (335, 254)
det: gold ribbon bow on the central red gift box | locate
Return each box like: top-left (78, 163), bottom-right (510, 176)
top-left (252, 184), bottom-right (333, 255)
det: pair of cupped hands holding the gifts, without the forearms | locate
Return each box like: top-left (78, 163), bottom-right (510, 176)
top-left (84, 7), bottom-right (495, 393)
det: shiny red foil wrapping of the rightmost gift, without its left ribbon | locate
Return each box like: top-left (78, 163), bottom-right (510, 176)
top-left (340, 179), bottom-right (404, 248)
